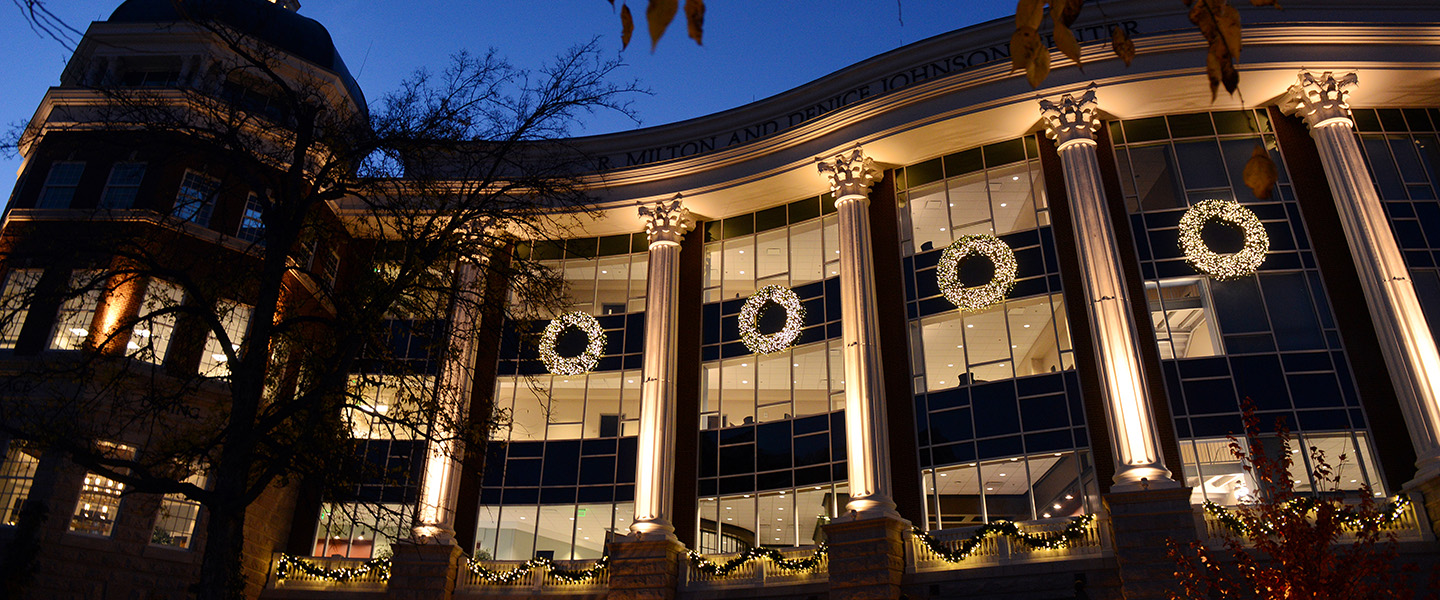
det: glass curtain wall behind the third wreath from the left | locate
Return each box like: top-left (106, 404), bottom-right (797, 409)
top-left (897, 137), bottom-right (1097, 529)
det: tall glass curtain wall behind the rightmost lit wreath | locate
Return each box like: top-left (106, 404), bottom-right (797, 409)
top-left (1109, 111), bottom-right (1388, 504)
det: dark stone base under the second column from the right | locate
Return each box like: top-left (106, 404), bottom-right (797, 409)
top-left (1104, 488), bottom-right (1197, 600)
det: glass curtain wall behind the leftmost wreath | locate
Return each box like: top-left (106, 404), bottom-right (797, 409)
top-left (475, 233), bottom-right (649, 560)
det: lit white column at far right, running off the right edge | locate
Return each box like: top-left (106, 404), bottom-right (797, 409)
top-left (1280, 72), bottom-right (1440, 481)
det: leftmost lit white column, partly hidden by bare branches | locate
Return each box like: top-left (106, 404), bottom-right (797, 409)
top-left (412, 259), bottom-right (484, 544)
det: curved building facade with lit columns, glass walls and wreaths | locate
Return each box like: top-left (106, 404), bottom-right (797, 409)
top-left (0, 0), bottom-right (1440, 599)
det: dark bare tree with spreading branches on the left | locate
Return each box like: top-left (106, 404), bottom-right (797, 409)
top-left (0, 0), bottom-right (638, 599)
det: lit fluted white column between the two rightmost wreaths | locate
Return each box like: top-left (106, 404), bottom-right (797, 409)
top-left (1040, 86), bottom-right (1179, 492)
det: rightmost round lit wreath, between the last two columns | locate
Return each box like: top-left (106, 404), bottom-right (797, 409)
top-left (1179, 200), bottom-right (1270, 281)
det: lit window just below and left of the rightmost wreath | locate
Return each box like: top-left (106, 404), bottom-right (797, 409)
top-left (1145, 278), bottom-right (1223, 360)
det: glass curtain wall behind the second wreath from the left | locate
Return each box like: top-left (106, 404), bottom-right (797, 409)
top-left (696, 201), bottom-right (848, 553)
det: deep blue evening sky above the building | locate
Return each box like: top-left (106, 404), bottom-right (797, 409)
top-left (0, 0), bottom-right (1015, 184)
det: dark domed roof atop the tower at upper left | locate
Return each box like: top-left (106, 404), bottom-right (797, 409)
top-left (107, 0), bottom-right (364, 109)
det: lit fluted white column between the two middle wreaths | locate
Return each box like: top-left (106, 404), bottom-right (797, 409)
top-left (816, 145), bottom-right (900, 518)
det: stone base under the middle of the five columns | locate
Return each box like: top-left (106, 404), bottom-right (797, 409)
top-left (825, 517), bottom-right (910, 600)
